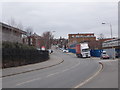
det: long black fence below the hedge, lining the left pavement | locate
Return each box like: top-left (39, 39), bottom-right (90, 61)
top-left (2, 48), bottom-right (49, 68)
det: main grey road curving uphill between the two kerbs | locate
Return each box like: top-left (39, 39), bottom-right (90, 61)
top-left (2, 50), bottom-right (100, 88)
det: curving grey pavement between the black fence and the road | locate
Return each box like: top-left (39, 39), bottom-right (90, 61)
top-left (0, 54), bottom-right (64, 77)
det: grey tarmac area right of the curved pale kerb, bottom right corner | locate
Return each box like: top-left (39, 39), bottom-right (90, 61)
top-left (81, 60), bottom-right (118, 88)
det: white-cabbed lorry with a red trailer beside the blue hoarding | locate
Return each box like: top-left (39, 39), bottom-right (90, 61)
top-left (76, 43), bottom-right (91, 58)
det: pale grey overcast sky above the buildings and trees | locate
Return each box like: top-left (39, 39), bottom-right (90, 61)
top-left (2, 2), bottom-right (118, 38)
